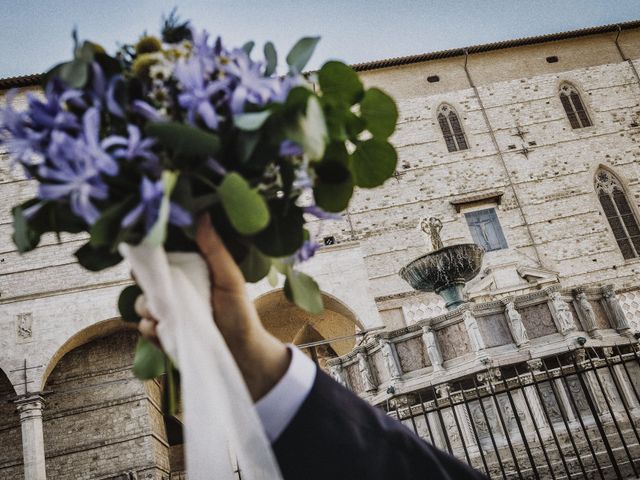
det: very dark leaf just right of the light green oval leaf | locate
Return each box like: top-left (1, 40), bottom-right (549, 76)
top-left (254, 199), bottom-right (304, 257)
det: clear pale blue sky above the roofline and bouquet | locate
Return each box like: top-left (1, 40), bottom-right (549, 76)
top-left (0, 0), bottom-right (640, 78)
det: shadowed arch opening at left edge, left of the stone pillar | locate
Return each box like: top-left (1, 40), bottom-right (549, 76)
top-left (0, 369), bottom-right (23, 479)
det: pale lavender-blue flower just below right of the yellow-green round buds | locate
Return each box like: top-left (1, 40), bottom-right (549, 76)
top-left (174, 57), bottom-right (229, 130)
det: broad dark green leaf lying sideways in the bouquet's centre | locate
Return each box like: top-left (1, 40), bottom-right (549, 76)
top-left (145, 122), bottom-right (220, 168)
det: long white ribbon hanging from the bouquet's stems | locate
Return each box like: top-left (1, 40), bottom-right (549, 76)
top-left (120, 244), bottom-right (282, 480)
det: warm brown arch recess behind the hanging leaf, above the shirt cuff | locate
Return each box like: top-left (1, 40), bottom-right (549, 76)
top-left (254, 289), bottom-right (363, 355)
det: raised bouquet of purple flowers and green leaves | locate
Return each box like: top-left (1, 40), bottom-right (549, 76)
top-left (0, 14), bottom-right (397, 478)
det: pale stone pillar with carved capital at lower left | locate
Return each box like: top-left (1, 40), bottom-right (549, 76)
top-left (16, 394), bottom-right (47, 480)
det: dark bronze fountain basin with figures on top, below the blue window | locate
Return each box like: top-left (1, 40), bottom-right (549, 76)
top-left (400, 217), bottom-right (484, 310)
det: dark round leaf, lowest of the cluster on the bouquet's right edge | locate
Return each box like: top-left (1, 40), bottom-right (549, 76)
top-left (313, 161), bottom-right (353, 212)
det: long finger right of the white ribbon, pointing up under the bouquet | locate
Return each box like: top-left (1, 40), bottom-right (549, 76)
top-left (196, 214), bottom-right (244, 291)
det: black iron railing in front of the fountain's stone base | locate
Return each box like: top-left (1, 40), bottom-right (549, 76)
top-left (380, 344), bottom-right (640, 480)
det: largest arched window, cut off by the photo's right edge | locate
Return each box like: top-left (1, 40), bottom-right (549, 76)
top-left (595, 168), bottom-right (640, 259)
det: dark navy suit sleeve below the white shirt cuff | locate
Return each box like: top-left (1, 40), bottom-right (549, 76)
top-left (273, 371), bottom-right (485, 480)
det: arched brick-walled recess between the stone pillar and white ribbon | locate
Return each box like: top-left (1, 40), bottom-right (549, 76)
top-left (43, 319), bottom-right (176, 480)
